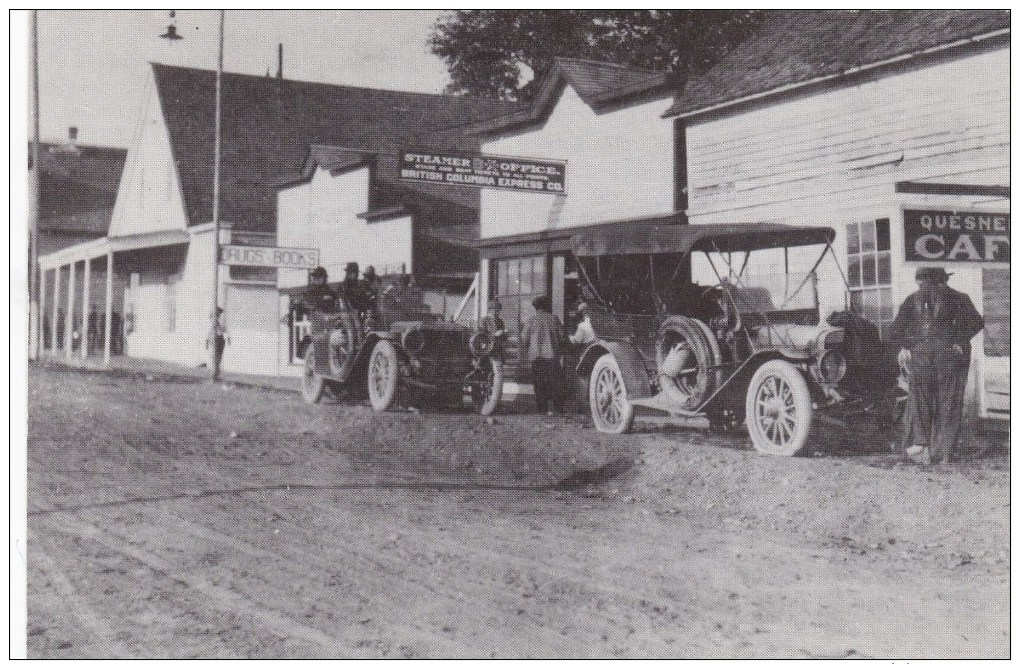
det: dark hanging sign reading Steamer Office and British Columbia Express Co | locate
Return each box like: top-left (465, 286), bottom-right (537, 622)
top-left (400, 151), bottom-right (566, 194)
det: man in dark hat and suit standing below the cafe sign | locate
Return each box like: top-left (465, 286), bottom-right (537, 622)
top-left (889, 267), bottom-right (984, 464)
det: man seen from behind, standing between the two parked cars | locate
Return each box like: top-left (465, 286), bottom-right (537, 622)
top-left (521, 295), bottom-right (563, 415)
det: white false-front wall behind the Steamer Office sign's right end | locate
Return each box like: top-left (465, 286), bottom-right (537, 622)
top-left (481, 86), bottom-right (673, 238)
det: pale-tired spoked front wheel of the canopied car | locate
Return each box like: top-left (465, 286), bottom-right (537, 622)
top-left (746, 360), bottom-right (814, 457)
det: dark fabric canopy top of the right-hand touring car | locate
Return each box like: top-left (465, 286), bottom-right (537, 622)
top-left (573, 223), bottom-right (835, 257)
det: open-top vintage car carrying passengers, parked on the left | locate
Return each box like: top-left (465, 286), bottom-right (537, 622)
top-left (298, 281), bottom-right (503, 415)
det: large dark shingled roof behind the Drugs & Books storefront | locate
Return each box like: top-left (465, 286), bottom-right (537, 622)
top-left (152, 63), bottom-right (516, 231)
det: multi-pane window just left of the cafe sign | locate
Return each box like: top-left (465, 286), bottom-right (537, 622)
top-left (847, 218), bottom-right (896, 339)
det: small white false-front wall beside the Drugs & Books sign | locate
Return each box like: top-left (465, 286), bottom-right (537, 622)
top-left (276, 167), bottom-right (413, 288)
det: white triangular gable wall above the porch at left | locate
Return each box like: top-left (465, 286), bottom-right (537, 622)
top-left (109, 78), bottom-right (188, 236)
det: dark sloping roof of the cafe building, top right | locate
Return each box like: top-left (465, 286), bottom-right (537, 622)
top-left (665, 9), bottom-right (1010, 117)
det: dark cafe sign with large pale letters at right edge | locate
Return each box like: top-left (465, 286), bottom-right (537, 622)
top-left (903, 210), bottom-right (1010, 264)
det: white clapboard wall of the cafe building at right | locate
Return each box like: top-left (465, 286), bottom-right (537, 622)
top-left (687, 48), bottom-right (1010, 416)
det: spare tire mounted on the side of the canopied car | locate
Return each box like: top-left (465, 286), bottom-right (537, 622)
top-left (655, 316), bottom-right (722, 410)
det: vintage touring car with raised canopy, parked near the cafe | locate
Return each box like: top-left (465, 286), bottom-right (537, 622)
top-left (572, 223), bottom-right (895, 456)
